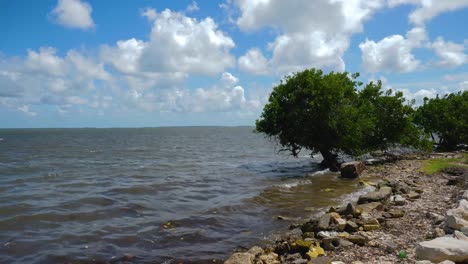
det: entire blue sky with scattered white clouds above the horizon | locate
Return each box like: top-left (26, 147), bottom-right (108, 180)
top-left (0, 0), bottom-right (468, 128)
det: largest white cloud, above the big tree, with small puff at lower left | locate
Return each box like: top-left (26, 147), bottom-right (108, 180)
top-left (236, 0), bottom-right (385, 74)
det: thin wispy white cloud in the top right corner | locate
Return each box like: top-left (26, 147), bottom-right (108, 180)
top-left (388, 0), bottom-right (468, 26)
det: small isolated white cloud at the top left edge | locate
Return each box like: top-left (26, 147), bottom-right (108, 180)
top-left (50, 0), bottom-right (94, 29)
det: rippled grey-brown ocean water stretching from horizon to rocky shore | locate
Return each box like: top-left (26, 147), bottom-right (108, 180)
top-left (0, 127), bottom-right (362, 263)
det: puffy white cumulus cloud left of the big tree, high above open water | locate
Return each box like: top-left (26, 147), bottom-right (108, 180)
top-left (140, 9), bottom-right (235, 74)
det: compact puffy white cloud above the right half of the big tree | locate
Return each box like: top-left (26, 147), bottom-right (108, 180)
top-left (359, 28), bottom-right (427, 72)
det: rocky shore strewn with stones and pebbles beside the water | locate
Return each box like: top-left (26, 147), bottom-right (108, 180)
top-left (225, 153), bottom-right (468, 264)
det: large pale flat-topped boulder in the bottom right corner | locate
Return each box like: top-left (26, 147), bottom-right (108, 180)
top-left (416, 237), bottom-right (468, 262)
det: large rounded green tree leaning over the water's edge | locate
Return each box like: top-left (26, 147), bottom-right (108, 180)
top-left (256, 69), bottom-right (430, 169)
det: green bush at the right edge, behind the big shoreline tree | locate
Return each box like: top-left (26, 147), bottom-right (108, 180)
top-left (415, 91), bottom-right (468, 150)
